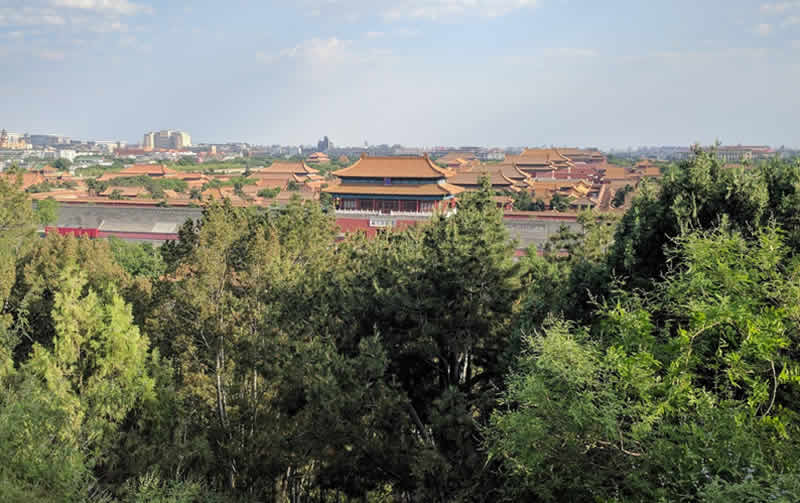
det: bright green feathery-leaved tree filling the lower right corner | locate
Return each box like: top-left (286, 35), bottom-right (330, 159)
top-left (489, 228), bottom-right (800, 502)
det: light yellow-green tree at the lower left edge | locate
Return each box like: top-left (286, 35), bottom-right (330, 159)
top-left (0, 268), bottom-right (153, 502)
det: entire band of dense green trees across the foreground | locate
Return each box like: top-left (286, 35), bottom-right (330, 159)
top-left (0, 153), bottom-right (800, 503)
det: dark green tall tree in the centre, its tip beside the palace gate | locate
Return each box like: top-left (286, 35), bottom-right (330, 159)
top-left (342, 179), bottom-right (521, 501)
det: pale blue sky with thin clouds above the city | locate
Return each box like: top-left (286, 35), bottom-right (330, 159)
top-left (0, 0), bottom-right (800, 148)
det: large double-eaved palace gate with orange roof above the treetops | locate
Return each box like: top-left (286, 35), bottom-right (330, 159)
top-left (323, 155), bottom-right (464, 234)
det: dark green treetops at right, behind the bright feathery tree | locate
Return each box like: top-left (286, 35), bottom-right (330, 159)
top-left (609, 150), bottom-right (800, 285)
